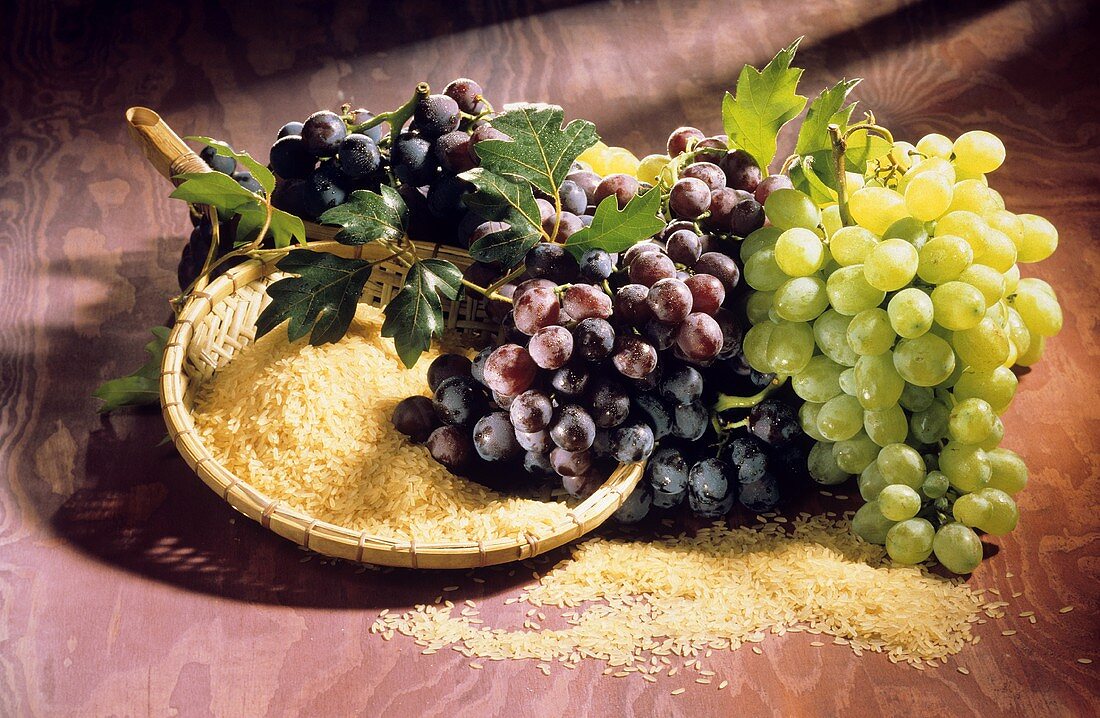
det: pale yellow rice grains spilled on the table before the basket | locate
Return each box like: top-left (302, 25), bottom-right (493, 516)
top-left (372, 516), bottom-right (997, 675)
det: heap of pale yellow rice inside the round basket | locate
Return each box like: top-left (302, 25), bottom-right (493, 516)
top-left (194, 305), bottom-right (569, 542)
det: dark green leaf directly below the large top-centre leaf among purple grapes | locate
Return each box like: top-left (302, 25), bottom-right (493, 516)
top-left (460, 167), bottom-right (545, 267)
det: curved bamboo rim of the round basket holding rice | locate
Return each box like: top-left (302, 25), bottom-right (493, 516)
top-left (160, 242), bottom-right (644, 568)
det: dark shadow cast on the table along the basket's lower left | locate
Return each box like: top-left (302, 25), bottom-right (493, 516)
top-left (52, 411), bottom-right (541, 609)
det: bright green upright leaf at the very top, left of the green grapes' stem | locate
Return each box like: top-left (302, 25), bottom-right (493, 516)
top-left (722, 37), bottom-right (806, 172)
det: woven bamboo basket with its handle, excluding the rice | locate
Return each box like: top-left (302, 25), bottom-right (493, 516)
top-left (127, 108), bottom-right (642, 568)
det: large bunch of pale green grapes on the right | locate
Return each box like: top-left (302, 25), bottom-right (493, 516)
top-left (741, 125), bottom-right (1063, 573)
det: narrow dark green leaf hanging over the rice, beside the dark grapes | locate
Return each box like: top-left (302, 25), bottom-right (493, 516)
top-left (382, 259), bottom-right (462, 367)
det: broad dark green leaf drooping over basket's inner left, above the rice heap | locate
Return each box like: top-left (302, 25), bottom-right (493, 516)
top-left (256, 250), bottom-right (372, 345)
